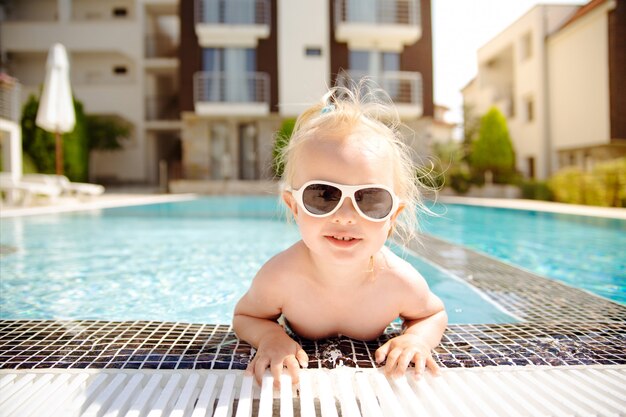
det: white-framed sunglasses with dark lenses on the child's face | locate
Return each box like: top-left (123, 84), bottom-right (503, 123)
top-left (287, 180), bottom-right (400, 222)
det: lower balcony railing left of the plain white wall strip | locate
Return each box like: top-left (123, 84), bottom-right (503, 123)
top-left (193, 72), bottom-right (270, 104)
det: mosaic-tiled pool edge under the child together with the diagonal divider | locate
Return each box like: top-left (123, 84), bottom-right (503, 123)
top-left (0, 232), bottom-right (626, 369)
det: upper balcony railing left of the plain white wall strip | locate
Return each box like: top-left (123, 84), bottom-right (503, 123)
top-left (195, 0), bottom-right (271, 26)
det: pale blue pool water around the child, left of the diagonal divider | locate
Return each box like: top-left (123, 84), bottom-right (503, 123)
top-left (0, 197), bottom-right (515, 323)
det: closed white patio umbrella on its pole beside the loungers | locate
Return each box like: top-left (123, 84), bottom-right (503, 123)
top-left (35, 43), bottom-right (76, 175)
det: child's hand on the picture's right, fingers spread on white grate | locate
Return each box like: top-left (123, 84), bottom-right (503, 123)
top-left (375, 333), bottom-right (440, 378)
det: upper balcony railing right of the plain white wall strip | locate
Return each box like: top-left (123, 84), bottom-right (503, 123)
top-left (335, 0), bottom-right (421, 26)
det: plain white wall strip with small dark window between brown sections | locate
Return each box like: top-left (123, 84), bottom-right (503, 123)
top-left (278, 0), bottom-right (330, 116)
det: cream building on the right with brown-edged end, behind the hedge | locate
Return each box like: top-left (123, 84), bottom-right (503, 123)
top-left (462, 0), bottom-right (626, 179)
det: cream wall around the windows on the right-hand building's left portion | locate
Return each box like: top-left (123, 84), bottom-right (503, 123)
top-left (465, 5), bottom-right (578, 179)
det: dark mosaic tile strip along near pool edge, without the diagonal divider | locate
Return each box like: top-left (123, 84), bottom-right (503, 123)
top-left (0, 320), bottom-right (626, 369)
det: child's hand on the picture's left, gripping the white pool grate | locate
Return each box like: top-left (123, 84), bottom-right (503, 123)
top-left (246, 332), bottom-right (309, 388)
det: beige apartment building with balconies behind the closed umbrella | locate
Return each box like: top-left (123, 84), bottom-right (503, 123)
top-left (0, 0), bottom-right (181, 183)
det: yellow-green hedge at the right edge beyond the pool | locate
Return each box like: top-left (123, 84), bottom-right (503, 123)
top-left (548, 158), bottom-right (626, 207)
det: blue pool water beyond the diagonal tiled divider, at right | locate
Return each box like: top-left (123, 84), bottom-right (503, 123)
top-left (421, 205), bottom-right (626, 304)
